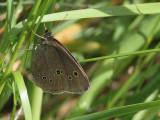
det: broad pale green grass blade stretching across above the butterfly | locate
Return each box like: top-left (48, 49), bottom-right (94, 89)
top-left (9, 3), bottom-right (160, 38)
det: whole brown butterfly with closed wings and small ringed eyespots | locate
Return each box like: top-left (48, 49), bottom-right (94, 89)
top-left (33, 30), bottom-right (90, 94)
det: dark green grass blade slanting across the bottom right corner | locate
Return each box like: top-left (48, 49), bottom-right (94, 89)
top-left (68, 100), bottom-right (160, 120)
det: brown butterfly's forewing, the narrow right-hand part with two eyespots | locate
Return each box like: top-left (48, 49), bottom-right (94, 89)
top-left (49, 39), bottom-right (90, 94)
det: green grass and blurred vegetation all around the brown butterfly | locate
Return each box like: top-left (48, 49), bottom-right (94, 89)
top-left (0, 0), bottom-right (160, 120)
